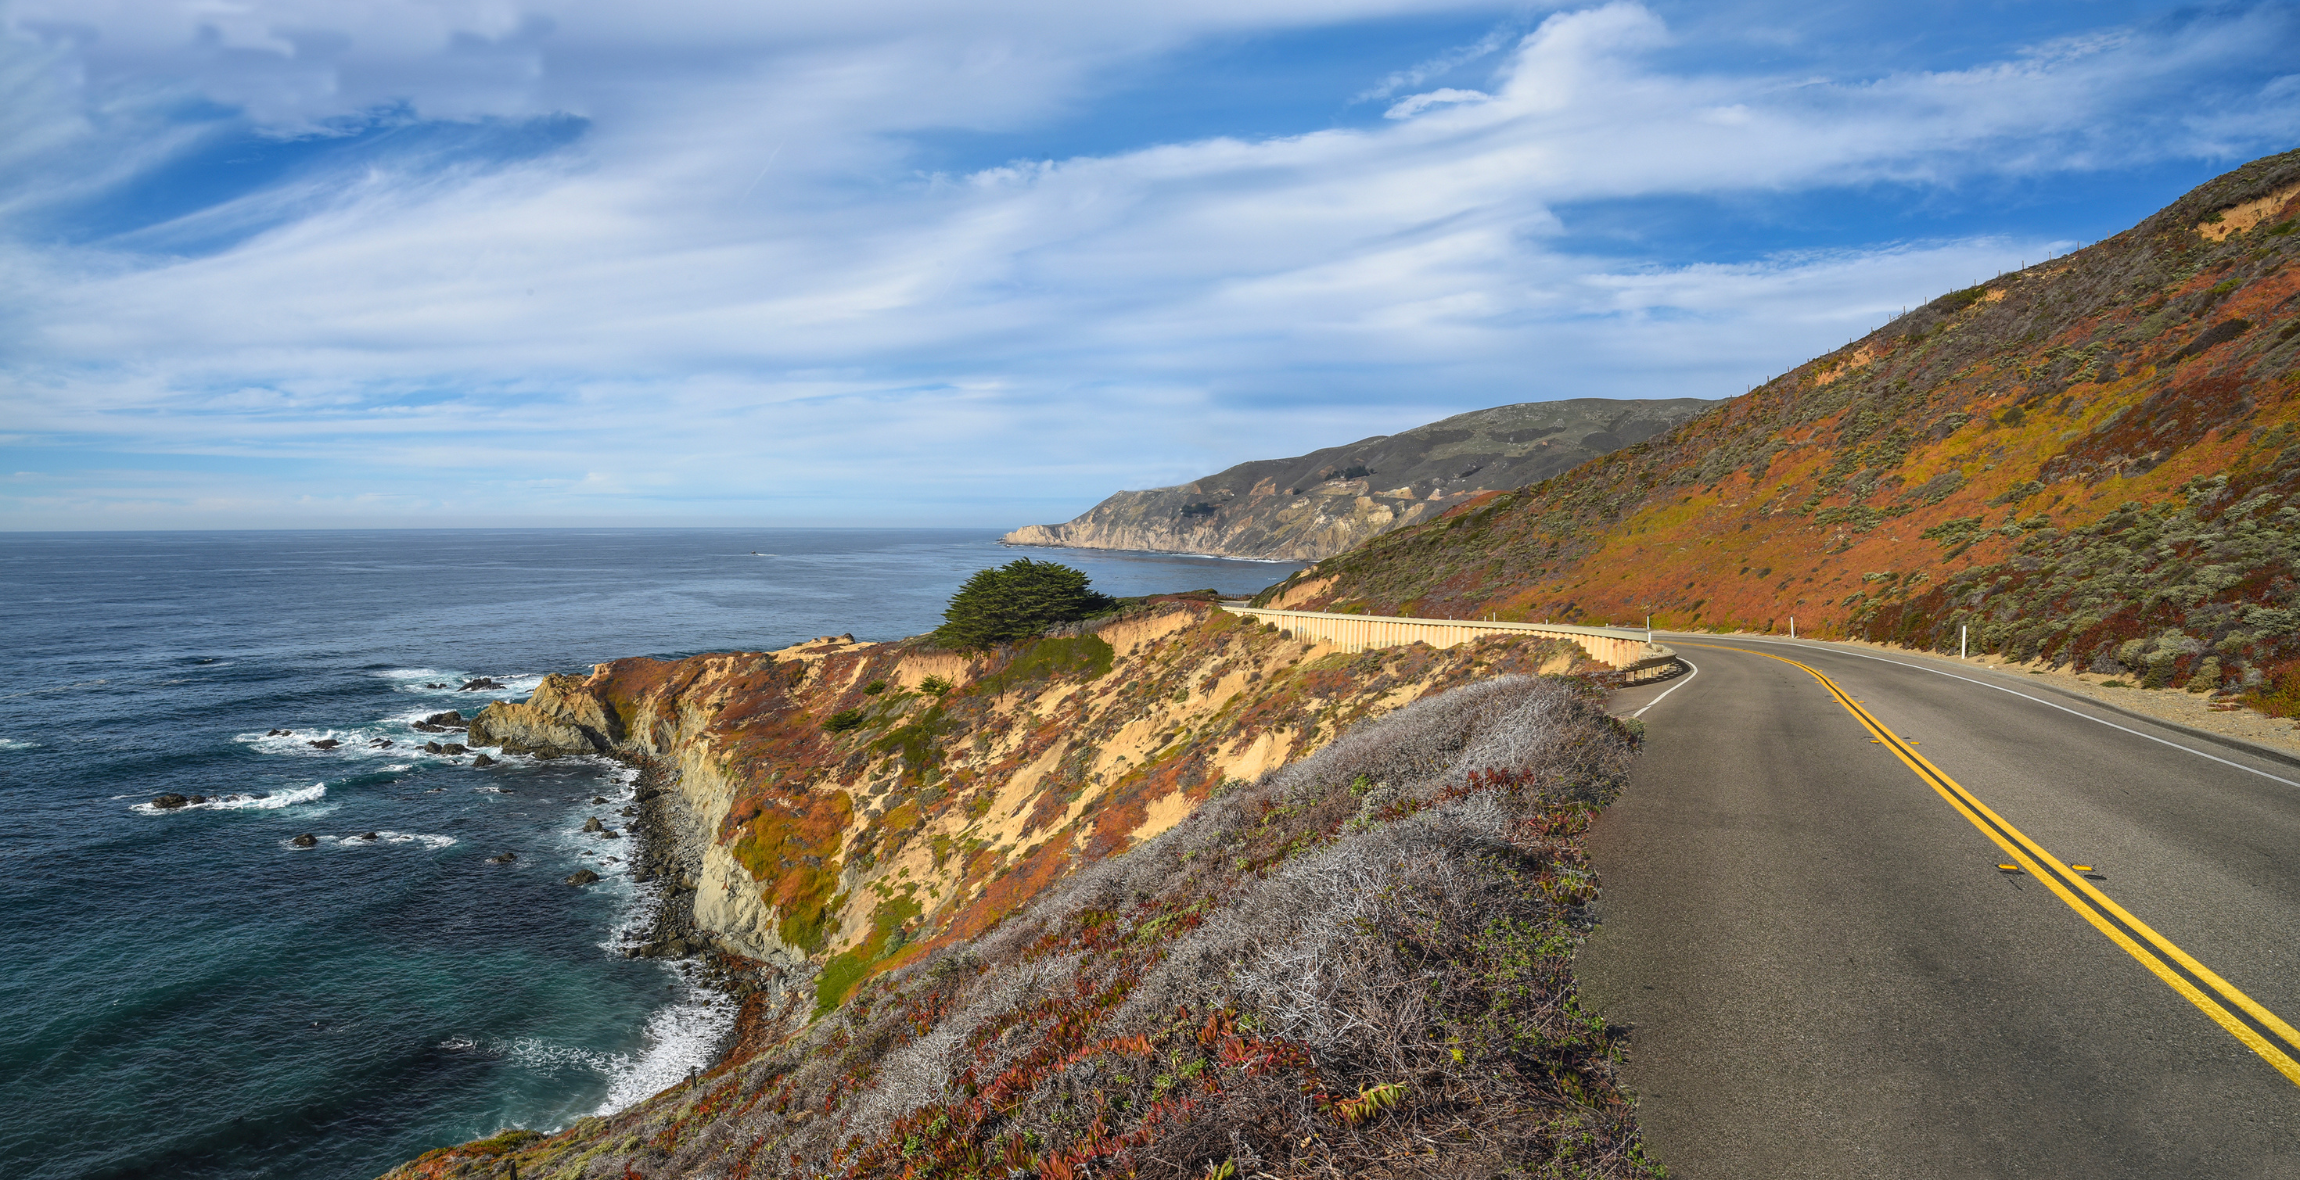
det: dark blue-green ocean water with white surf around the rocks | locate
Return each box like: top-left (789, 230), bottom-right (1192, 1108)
top-left (0, 529), bottom-right (1295, 1180)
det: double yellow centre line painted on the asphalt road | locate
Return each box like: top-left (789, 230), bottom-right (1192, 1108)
top-left (1684, 644), bottom-right (2300, 1086)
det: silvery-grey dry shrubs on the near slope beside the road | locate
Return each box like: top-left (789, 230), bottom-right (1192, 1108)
top-left (1116, 676), bottom-right (1626, 1053)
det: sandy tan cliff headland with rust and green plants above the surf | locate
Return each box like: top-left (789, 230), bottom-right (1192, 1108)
top-left (469, 605), bottom-right (1576, 1003)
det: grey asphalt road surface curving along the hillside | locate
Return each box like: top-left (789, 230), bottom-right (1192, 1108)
top-left (1580, 635), bottom-right (2300, 1180)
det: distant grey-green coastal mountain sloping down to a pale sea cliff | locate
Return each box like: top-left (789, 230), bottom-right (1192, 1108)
top-left (1005, 398), bottom-right (1716, 561)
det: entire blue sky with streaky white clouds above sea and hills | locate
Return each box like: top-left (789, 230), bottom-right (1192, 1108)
top-left (0, 0), bottom-right (2300, 529)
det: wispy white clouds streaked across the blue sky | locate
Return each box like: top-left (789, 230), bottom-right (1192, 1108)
top-left (0, 0), bottom-right (2291, 527)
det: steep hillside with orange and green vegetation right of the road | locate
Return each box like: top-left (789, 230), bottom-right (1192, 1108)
top-left (1270, 152), bottom-right (2300, 699)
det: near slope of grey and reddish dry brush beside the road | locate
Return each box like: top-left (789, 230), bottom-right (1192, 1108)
top-left (432, 676), bottom-right (1661, 1180)
